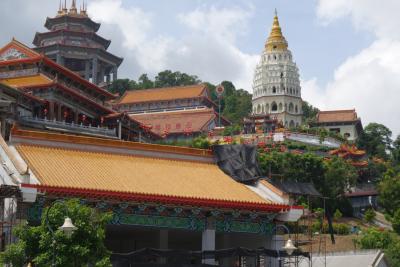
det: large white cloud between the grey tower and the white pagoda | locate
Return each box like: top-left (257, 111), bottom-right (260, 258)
top-left (88, 0), bottom-right (258, 90)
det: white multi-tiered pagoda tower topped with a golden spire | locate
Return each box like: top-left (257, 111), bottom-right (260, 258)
top-left (252, 11), bottom-right (303, 128)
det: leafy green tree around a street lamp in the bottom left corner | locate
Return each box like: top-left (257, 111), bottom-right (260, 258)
top-left (0, 199), bottom-right (111, 267)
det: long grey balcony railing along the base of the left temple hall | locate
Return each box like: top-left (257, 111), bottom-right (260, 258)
top-left (19, 116), bottom-right (117, 138)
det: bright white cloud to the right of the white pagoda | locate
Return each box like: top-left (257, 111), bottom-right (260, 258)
top-left (302, 0), bottom-right (400, 135)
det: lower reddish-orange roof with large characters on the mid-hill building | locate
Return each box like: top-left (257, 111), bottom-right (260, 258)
top-left (129, 108), bottom-right (216, 135)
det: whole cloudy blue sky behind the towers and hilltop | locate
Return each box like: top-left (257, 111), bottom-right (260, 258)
top-left (0, 0), bottom-right (400, 134)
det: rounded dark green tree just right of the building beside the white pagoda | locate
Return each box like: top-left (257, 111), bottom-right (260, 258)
top-left (357, 123), bottom-right (392, 159)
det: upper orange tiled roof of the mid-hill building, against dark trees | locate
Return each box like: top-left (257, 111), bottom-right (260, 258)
top-left (118, 84), bottom-right (206, 105)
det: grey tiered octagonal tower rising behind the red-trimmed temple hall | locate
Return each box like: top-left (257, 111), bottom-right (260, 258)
top-left (33, 0), bottom-right (123, 86)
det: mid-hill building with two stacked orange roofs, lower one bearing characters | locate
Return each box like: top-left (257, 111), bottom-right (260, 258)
top-left (114, 84), bottom-right (230, 140)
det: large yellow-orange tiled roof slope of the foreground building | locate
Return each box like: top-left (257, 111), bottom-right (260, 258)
top-left (16, 144), bottom-right (270, 204)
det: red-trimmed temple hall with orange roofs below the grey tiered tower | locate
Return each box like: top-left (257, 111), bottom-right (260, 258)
top-left (0, 39), bottom-right (155, 140)
